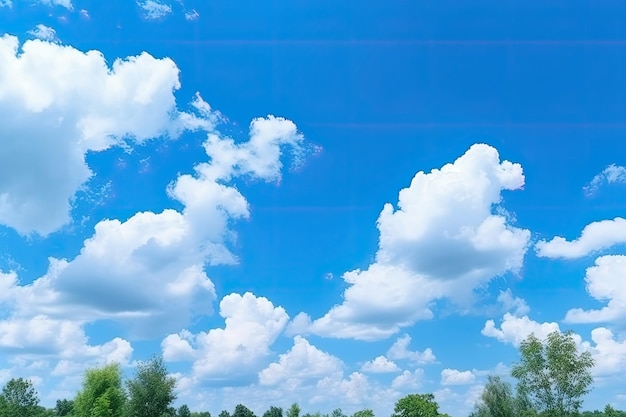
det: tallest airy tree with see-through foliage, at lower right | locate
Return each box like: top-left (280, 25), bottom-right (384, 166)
top-left (511, 331), bottom-right (594, 417)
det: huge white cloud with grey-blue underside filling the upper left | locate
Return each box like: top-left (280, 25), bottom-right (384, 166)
top-left (0, 35), bottom-right (200, 235)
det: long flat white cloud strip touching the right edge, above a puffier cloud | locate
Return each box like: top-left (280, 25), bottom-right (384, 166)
top-left (535, 217), bottom-right (626, 259)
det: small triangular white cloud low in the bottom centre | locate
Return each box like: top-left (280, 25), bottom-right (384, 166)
top-left (259, 336), bottom-right (343, 387)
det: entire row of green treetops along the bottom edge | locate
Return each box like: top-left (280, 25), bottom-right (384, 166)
top-left (0, 332), bottom-right (626, 417)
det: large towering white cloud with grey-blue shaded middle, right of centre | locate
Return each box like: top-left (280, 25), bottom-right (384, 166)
top-left (310, 144), bottom-right (530, 340)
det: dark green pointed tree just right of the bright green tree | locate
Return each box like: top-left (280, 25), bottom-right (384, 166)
top-left (126, 356), bottom-right (176, 417)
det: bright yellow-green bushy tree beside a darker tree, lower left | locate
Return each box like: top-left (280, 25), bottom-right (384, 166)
top-left (73, 364), bottom-right (126, 417)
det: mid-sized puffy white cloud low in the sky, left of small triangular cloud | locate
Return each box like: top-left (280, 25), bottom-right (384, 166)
top-left (161, 293), bottom-right (288, 382)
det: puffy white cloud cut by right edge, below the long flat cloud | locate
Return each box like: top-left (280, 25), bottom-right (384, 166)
top-left (565, 255), bottom-right (626, 323)
